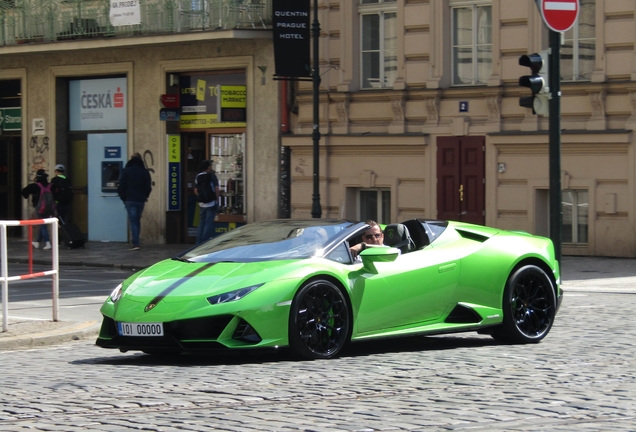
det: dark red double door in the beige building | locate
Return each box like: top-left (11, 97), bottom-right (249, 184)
top-left (437, 137), bottom-right (486, 225)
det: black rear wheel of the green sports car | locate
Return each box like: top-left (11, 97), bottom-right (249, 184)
top-left (491, 265), bottom-right (556, 343)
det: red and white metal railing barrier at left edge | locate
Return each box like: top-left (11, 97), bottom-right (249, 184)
top-left (0, 218), bottom-right (60, 332)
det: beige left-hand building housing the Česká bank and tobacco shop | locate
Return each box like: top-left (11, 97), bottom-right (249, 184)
top-left (0, 1), bottom-right (280, 245)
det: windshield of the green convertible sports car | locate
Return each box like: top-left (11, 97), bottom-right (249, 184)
top-left (178, 219), bottom-right (354, 262)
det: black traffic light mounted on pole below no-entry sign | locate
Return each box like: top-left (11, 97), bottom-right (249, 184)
top-left (519, 51), bottom-right (550, 116)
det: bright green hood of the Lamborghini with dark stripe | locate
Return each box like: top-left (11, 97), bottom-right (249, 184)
top-left (123, 260), bottom-right (298, 303)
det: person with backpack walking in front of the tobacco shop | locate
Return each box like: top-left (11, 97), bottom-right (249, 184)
top-left (194, 160), bottom-right (219, 244)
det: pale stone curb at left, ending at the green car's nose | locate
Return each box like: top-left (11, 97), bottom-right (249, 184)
top-left (0, 321), bottom-right (101, 351)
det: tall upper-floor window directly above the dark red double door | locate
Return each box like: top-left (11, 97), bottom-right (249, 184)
top-left (451, 2), bottom-right (492, 85)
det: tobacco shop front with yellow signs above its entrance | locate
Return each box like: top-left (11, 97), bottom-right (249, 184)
top-left (164, 70), bottom-right (248, 243)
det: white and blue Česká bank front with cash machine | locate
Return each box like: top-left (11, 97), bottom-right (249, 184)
top-left (66, 76), bottom-right (129, 242)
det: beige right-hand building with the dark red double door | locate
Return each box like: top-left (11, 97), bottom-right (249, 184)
top-left (282, 0), bottom-right (636, 257)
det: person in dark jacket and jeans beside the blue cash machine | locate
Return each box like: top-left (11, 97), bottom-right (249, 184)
top-left (117, 153), bottom-right (152, 250)
